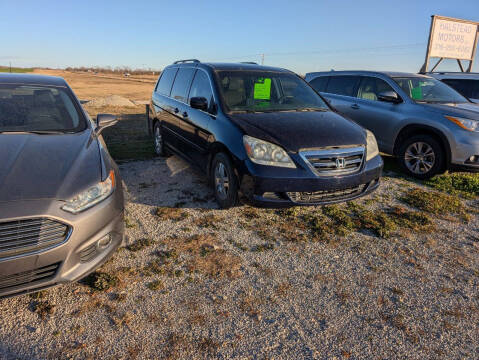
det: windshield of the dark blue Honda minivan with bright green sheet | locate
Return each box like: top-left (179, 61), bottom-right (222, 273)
top-left (217, 70), bottom-right (328, 112)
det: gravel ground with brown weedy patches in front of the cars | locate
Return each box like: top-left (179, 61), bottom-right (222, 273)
top-left (0, 157), bottom-right (479, 359)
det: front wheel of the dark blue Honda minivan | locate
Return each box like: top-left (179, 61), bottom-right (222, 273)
top-left (211, 152), bottom-right (238, 209)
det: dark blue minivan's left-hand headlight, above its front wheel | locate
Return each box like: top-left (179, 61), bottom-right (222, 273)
top-left (243, 135), bottom-right (296, 168)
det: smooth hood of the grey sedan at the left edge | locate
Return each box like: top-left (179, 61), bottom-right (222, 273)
top-left (0, 129), bottom-right (101, 202)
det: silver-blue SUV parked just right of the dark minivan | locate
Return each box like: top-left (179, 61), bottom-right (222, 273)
top-left (306, 71), bottom-right (479, 179)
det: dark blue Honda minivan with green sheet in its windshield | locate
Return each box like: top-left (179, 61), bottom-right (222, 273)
top-left (148, 60), bottom-right (383, 208)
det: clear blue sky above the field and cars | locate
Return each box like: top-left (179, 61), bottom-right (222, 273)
top-left (0, 0), bottom-right (479, 73)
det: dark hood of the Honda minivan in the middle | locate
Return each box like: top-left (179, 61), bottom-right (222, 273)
top-left (229, 111), bottom-right (366, 152)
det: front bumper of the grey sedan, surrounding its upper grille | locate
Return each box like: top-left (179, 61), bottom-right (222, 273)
top-left (0, 186), bottom-right (124, 298)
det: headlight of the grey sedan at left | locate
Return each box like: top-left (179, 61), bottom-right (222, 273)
top-left (62, 170), bottom-right (115, 214)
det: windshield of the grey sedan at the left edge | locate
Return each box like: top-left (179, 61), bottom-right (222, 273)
top-left (0, 84), bottom-right (86, 134)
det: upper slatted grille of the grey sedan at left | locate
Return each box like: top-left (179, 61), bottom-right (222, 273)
top-left (0, 218), bottom-right (70, 259)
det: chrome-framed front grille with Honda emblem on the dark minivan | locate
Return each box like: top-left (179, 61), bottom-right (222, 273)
top-left (299, 146), bottom-right (364, 176)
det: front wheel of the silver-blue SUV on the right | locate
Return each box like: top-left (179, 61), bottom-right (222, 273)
top-left (397, 134), bottom-right (446, 180)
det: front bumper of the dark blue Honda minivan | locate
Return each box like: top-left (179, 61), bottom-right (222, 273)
top-left (241, 155), bottom-right (383, 207)
